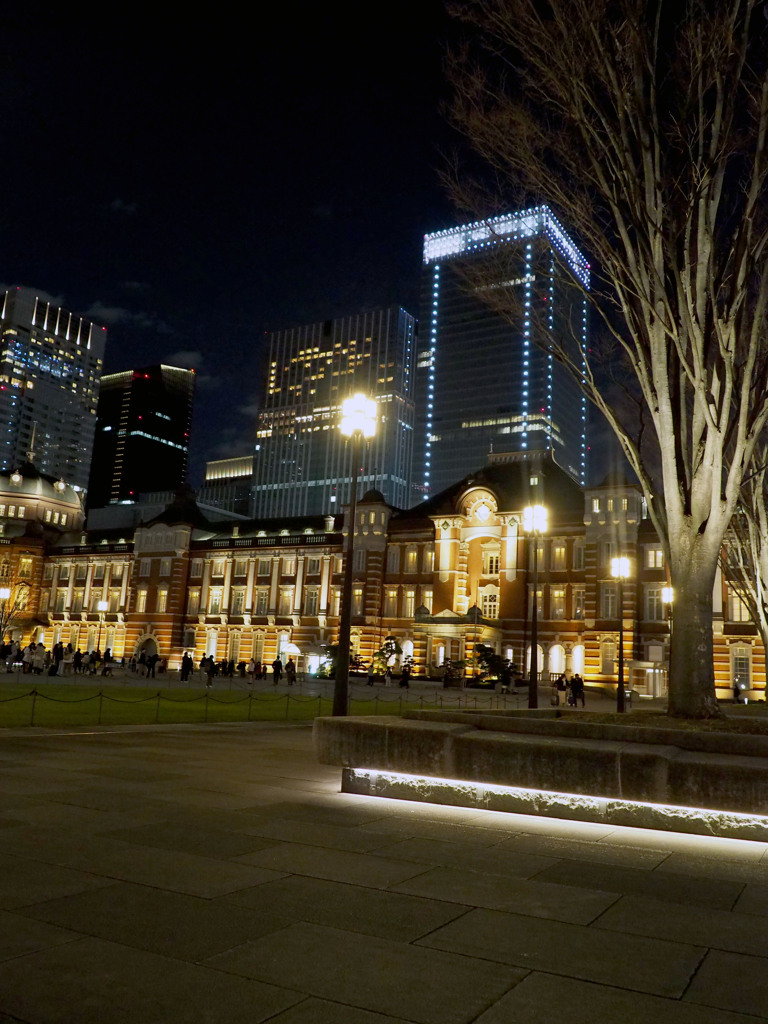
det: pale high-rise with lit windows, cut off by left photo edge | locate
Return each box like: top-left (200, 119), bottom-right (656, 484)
top-left (0, 288), bottom-right (106, 488)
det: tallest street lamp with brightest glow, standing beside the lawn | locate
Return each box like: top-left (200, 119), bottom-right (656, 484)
top-left (333, 394), bottom-right (376, 716)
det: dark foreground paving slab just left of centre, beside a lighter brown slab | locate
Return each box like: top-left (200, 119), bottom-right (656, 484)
top-left (217, 874), bottom-right (469, 942)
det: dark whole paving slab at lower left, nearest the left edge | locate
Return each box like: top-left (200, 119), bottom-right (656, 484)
top-left (16, 884), bottom-right (291, 963)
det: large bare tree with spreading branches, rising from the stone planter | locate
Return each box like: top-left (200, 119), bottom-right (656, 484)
top-left (450, 0), bottom-right (768, 717)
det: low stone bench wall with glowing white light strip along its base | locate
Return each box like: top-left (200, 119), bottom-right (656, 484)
top-left (314, 711), bottom-right (768, 839)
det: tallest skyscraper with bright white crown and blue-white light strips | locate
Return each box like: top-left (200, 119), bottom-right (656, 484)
top-left (416, 206), bottom-right (589, 497)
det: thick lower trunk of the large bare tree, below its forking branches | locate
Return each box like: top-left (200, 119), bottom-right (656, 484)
top-left (669, 546), bottom-right (720, 718)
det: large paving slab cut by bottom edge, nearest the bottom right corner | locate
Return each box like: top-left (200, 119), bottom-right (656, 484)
top-left (476, 973), bottom-right (756, 1024)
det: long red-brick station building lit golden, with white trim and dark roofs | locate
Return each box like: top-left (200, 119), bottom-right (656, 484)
top-left (0, 453), bottom-right (766, 702)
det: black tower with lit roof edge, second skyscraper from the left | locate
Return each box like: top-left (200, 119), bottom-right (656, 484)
top-left (88, 366), bottom-right (195, 508)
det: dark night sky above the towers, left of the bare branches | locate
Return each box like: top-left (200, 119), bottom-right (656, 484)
top-left (0, 0), bottom-right (456, 484)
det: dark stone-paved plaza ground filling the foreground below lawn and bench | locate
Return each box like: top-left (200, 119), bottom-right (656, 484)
top-left (0, 724), bottom-right (768, 1024)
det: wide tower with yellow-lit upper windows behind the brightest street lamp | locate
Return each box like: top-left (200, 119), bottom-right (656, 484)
top-left (254, 306), bottom-right (416, 517)
